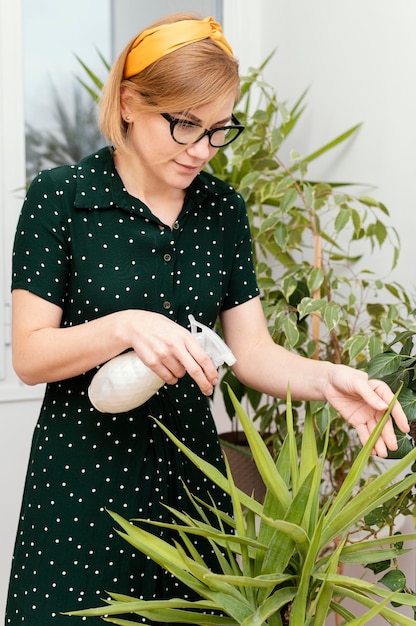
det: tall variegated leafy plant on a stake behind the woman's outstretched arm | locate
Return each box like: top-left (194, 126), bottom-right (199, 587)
top-left (209, 59), bottom-right (415, 500)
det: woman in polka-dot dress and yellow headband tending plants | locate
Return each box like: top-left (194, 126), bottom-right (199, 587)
top-left (6, 14), bottom-right (408, 626)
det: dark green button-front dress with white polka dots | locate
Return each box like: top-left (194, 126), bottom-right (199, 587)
top-left (6, 148), bottom-right (258, 626)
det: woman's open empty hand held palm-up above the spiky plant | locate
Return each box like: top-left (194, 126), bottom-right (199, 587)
top-left (323, 365), bottom-right (409, 457)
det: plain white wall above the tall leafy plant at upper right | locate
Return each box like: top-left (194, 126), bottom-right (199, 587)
top-left (224, 0), bottom-right (416, 293)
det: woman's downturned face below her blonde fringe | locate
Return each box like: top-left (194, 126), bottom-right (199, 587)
top-left (122, 97), bottom-right (234, 190)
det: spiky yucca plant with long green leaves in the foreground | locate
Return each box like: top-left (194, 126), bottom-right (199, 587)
top-left (69, 391), bottom-right (416, 626)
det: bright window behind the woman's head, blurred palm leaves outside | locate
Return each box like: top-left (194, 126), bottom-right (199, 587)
top-left (22, 0), bottom-right (222, 180)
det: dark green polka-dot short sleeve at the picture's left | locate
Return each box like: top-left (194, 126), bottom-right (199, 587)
top-left (12, 168), bottom-right (73, 307)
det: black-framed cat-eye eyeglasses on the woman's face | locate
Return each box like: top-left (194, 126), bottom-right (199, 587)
top-left (161, 113), bottom-right (244, 148)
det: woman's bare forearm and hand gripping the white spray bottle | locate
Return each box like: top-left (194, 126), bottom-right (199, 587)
top-left (12, 290), bottom-right (218, 395)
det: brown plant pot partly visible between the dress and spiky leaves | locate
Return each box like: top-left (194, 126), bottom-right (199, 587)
top-left (220, 430), bottom-right (271, 502)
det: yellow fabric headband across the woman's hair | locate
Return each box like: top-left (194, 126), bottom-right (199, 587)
top-left (124, 17), bottom-right (233, 78)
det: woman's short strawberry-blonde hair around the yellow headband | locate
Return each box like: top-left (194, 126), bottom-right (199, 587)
top-left (99, 13), bottom-right (239, 151)
